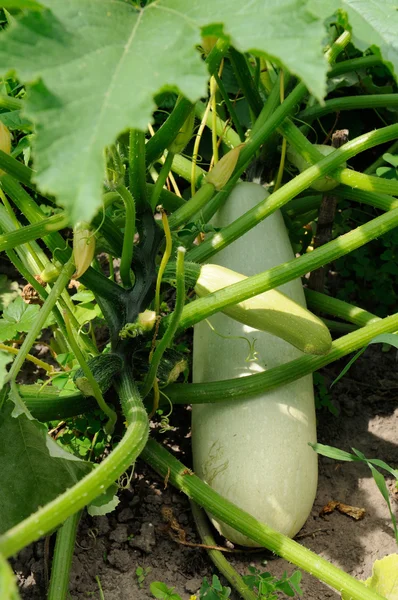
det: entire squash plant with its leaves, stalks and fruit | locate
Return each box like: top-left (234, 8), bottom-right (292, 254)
top-left (0, 0), bottom-right (398, 600)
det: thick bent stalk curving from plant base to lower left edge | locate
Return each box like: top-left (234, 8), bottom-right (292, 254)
top-left (0, 367), bottom-right (149, 557)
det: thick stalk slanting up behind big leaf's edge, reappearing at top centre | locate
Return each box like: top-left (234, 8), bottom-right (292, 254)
top-left (146, 38), bottom-right (229, 167)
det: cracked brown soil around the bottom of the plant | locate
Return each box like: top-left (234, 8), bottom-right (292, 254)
top-left (10, 346), bottom-right (398, 600)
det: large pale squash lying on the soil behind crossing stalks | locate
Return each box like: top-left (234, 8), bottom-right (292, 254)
top-left (192, 183), bottom-right (318, 546)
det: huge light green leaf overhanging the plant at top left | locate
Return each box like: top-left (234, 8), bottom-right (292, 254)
top-left (0, 0), bottom-right (326, 222)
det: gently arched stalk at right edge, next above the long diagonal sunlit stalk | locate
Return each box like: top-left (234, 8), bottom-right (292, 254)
top-left (297, 94), bottom-right (398, 123)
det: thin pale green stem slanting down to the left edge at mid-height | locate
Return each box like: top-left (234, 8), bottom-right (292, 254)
top-left (7, 259), bottom-right (75, 381)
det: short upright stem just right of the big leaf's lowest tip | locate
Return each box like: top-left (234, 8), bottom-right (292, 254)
top-left (129, 129), bottom-right (147, 212)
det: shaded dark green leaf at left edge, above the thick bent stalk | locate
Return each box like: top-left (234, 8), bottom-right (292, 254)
top-left (0, 393), bottom-right (92, 533)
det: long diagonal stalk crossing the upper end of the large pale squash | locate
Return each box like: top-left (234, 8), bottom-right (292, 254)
top-left (187, 122), bottom-right (398, 262)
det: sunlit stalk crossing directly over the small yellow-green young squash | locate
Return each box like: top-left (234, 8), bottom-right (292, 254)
top-left (180, 208), bottom-right (398, 330)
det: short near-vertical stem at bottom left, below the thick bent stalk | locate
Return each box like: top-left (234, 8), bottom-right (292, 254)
top-left (47, 511), bottom-right (82, 600)
